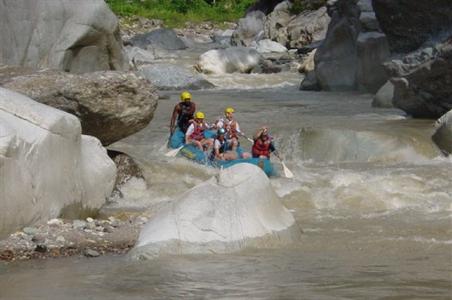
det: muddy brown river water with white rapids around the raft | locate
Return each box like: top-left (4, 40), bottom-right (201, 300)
top-left (0, 68), bottom-right (452, 299)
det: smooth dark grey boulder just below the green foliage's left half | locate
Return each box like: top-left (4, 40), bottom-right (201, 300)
top-left (127, 28), bottom-right (187, 50)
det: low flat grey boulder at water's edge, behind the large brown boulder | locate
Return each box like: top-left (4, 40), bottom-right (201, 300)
top-left (139, 64), bottom-right (215, 90)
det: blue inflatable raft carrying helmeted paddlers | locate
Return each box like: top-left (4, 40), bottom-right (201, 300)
top-left (169, 129), bottom-right (277, 176)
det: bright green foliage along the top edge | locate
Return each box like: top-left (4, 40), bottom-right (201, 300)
top-left (106, 0), bottom-right (255, 27)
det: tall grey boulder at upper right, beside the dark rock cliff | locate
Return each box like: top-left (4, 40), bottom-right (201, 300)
top-left (315, 0), bottom-right (390, 92)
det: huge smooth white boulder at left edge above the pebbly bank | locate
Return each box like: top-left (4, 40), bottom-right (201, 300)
top-left (0, 88), bottom-right (116, 236)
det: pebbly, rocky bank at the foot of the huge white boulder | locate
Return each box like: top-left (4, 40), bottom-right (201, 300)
top-left (0, 215), bottom-right (148, 261)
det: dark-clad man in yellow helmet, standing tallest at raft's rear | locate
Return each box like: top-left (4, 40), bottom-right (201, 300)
top-left (170, 91), bottom-right (196, 135)
